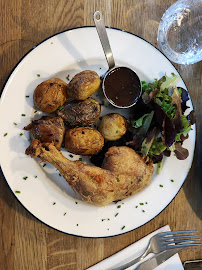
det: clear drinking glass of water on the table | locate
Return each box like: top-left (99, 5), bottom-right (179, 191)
top-left (157, 0), bottom-right (202, 64)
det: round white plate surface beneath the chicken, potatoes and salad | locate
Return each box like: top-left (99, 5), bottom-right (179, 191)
top-left (0, 27), bottom-right (195, 237)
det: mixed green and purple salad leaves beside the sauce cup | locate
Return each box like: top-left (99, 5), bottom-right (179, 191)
top-left (126, 74), bottom-right (195, 173)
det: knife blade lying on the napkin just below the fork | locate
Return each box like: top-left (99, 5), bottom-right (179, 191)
top-left (135, 248), bottom-right (182, 270)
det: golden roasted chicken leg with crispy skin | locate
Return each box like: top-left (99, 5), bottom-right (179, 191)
top-left (25, 140), bottom-right (153, 206)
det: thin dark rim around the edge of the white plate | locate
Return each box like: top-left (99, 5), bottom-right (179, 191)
top-left (0, 25), bottom-right (197, 239)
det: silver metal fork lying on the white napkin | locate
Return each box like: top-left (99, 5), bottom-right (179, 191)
top-left (113, 230), bottom-right (202, 270)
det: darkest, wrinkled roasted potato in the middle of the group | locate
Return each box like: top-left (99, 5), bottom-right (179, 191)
top-left (57, 98), bottom-right (101, 126)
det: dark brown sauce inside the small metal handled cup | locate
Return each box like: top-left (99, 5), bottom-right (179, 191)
top-left (103, 67), bottom-right (141, 107)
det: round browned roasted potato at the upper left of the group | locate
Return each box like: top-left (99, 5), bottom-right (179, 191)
top-left (33, 78), bottom-right (67, 113)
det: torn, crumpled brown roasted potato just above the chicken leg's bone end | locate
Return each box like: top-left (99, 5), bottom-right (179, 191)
top-left (24, 116), bottom-right (65, 149)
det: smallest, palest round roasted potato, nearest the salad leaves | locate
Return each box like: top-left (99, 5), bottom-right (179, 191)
top-left (98, 113), bottom-right (127, 141)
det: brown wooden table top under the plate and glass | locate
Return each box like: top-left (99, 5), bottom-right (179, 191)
top-left (0, 0), bottom-right (202, 270)
